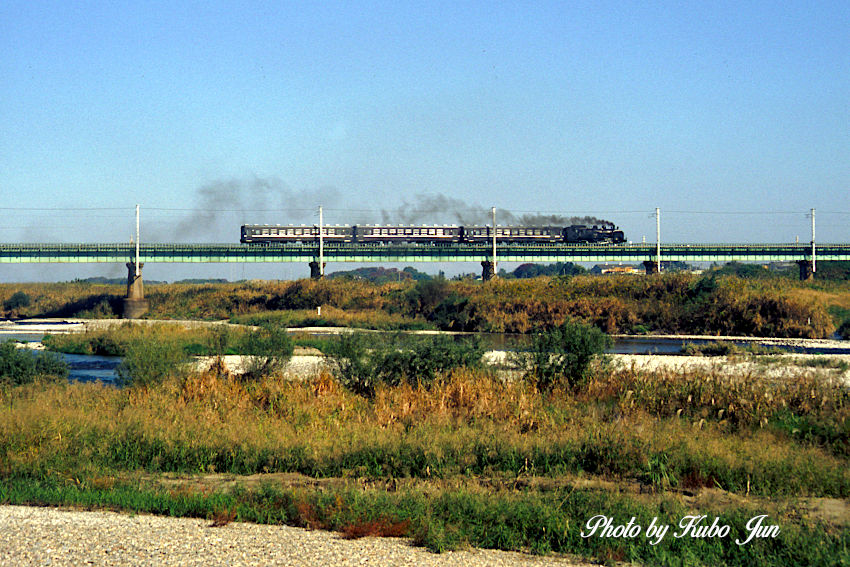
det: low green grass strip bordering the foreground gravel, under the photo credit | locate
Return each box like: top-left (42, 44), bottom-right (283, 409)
top-left (0, 478), bottom-right (850, 566)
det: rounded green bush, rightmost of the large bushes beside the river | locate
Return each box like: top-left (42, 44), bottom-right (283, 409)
top-left (513, 321), bottom-right (612, 391)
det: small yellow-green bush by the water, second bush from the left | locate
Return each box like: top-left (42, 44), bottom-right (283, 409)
top-left (115, 338), bottom-right (188, 387)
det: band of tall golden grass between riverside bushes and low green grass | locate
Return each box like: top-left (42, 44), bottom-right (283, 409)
top-left (0, 364), bottom-right (850, 497)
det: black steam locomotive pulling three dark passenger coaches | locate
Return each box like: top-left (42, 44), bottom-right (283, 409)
top-left (240, 223), bottom-right (626, 245)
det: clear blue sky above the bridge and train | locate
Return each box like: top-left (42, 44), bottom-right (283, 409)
top-left (0, 0), bottom-right (850, 279)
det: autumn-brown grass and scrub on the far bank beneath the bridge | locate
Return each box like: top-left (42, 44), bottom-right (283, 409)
top-left (0, 273), bottom-right (850, 338)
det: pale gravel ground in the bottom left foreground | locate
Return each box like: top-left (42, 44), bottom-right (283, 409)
top-left (0, 506), bottom-right (590, 567)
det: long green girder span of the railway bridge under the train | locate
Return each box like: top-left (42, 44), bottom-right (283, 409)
top-left (0, 243), bottom-right (850, 263)
